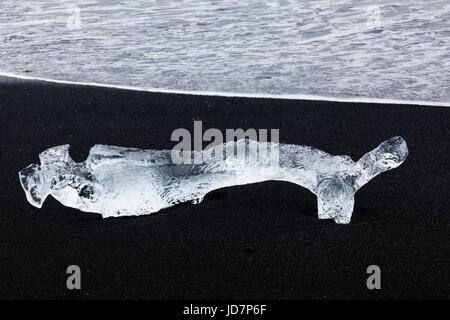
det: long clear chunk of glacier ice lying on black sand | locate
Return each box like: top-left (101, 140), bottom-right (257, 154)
top-left (19, 137), bottom-right (408, 224)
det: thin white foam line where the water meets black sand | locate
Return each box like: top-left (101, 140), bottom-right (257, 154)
top-left (0, 71), bottom-right (450, 107)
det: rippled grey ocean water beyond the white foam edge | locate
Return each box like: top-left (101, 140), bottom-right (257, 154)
top-left (0, 0), bottom-right (450, 102)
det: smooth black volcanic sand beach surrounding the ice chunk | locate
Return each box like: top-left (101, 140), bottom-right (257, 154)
top-left (0, 79), bottom-right (450, 299)
